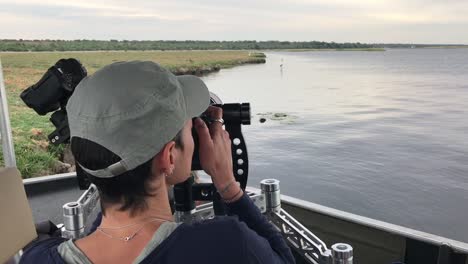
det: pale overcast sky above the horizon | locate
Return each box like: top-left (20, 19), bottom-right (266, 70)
top-left (0, 0), bottom-right (468, 44)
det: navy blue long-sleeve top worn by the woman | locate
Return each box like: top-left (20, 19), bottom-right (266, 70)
top-left (21, 194), bottom-right (294, 264)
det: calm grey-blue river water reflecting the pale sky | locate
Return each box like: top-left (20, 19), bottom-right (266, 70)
top-left (204, 49), bottom-right (468, 242)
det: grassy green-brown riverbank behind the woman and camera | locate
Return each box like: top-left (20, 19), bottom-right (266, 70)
top-left (0, 51), bottom-right (265, 178)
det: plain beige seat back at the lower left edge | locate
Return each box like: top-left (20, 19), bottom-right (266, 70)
top-left (0, 168), bottom-right (37, 263)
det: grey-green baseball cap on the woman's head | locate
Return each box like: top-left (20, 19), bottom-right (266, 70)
top-left (67, 61), bottom-right (210, 178)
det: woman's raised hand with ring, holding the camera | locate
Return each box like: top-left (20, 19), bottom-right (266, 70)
top-left (194, 106), bottom-right (235, 190)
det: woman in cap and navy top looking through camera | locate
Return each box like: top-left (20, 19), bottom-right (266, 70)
top-left (22, 61), bottom-right (294, 263)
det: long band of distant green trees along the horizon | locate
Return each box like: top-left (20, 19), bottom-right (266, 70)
top-left (0, 39), bottom-right (375, 51)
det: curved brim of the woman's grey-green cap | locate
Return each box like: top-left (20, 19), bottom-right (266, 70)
top-left (177, 75), bottom-right (210, 117)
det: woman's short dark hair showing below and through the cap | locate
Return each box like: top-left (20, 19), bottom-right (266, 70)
top-left (71, 131), bottom-right (183, 215)
